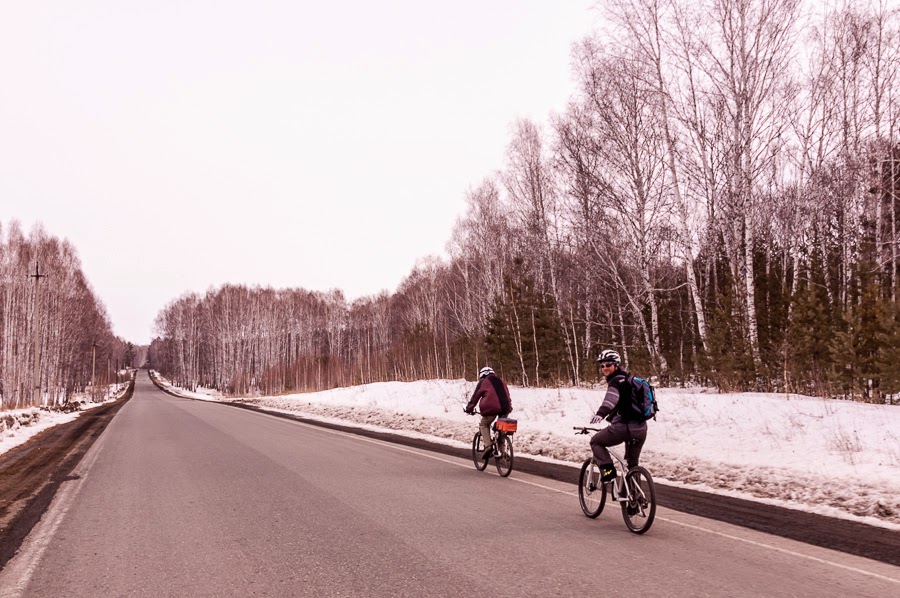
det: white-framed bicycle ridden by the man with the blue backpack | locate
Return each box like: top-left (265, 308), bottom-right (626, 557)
top-left (573, 426), bottom-right (656, 534)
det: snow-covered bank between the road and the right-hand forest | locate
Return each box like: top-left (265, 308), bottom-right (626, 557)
top-left (149, 380), bottom-right (900, 531)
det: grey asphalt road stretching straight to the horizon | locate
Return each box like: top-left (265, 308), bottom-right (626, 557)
top-left (0, 372), bottom-right (900, 597)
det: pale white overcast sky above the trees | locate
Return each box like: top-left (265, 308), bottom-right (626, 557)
top-left (0, 0), bottom-right (599, 343)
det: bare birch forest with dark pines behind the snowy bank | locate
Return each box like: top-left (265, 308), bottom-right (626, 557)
top-left (151, 0), bottom-right (900, 402)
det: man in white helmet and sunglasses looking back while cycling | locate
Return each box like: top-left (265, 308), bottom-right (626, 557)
top-left (591, 349), bottom-right (647, 482)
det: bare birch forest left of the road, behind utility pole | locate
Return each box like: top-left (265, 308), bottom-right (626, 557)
top-left (0, 221), bottom-right (135, 409)
